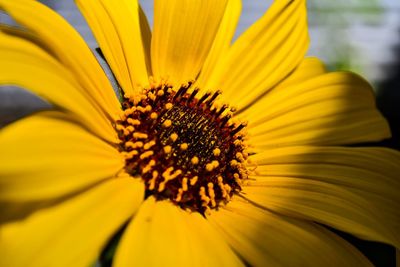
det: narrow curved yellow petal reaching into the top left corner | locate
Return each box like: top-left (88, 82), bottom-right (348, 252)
top-left (0, 0), bottom-right (120, 118)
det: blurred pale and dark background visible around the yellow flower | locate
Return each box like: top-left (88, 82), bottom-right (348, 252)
top-left (0, 0), bottom-right (400, 266)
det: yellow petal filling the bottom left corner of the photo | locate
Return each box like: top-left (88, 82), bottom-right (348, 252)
top-left (0, 178), bottom-right (144, 267)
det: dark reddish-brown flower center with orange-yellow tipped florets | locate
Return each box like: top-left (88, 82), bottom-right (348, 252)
top-left (115, 83), bottom-right (247, 213)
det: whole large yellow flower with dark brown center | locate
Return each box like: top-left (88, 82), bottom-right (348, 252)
top-left (0, 0), bottom-right (400, 267)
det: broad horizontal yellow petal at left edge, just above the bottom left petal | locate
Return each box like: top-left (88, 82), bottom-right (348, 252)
top-left (0, 112), bottom-right (124, 201)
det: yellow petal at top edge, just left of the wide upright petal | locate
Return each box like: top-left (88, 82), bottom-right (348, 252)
top-left (76, 0), bottom-right (151, 94)
